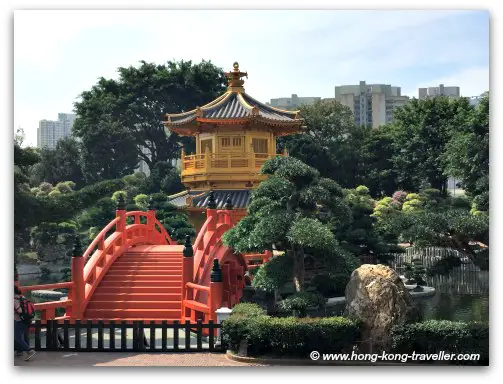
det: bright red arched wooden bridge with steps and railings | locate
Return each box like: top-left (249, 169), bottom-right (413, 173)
top-left (20, 198), bottom-right (272, 322)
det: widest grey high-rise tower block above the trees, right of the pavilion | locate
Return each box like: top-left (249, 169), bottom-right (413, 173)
top-left (335, 81), bottom-right (409, 128)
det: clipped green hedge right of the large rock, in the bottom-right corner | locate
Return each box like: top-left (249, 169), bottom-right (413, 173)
top-left (391, 320), bottom-right (489, 364)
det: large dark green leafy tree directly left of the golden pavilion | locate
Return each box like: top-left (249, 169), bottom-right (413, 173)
top-left (73, 61), bottom-right (225, 180)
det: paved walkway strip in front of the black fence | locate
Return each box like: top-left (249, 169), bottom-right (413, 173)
top-left (13, 352), bottom-right (266, 367)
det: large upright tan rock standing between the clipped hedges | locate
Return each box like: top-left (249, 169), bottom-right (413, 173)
top-left (344, 264), bottom-right (414, 350)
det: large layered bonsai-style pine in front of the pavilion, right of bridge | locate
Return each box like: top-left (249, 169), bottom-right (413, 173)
top-left (223, 157), bottom-right (351, 292)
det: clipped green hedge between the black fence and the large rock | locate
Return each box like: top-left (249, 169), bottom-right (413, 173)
top-left (222, 306), bottom-right (360, 358)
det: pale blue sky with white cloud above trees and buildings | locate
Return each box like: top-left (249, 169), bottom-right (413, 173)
top-left (14, 10), bottom-right (489, 145)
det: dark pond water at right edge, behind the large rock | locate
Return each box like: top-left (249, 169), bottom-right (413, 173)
top-left (327, 265), bottom-right (489, 322)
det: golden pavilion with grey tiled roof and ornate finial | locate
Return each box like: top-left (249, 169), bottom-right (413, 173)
top-left (163, 63), bottom-right (303, 227)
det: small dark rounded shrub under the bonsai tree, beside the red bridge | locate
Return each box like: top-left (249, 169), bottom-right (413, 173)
top-left (254, 254), bottom-right (293, 292)
